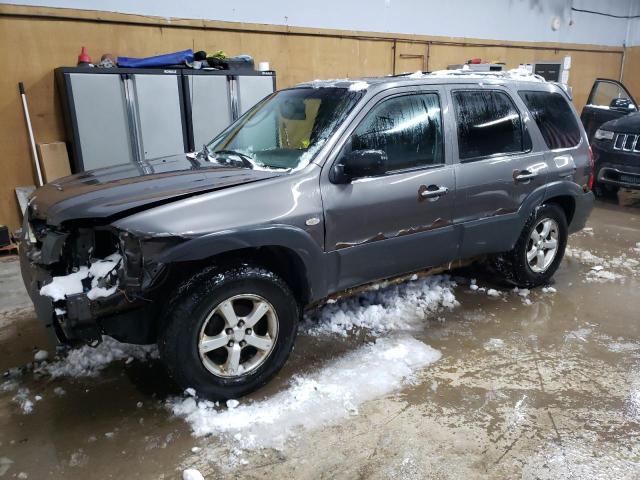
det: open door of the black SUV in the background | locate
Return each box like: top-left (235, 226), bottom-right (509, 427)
top-left (580, 78), bottom-right (638, 142)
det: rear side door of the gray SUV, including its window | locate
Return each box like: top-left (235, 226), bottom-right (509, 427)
top-left (449, 85), bottom-right (548, 258)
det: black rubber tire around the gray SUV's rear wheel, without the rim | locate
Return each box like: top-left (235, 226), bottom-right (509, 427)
top-left (491, 203), bottom-right (568, 288)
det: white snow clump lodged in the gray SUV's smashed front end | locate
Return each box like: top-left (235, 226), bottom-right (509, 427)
top-left (40, 253), bottom-right (122, 302)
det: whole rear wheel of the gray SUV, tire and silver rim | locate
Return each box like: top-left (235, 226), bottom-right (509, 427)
top-left (491, 203), bottom-right (568, 288)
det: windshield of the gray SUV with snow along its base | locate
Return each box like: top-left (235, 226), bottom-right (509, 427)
top-left (207, 87), bottom-right (365, 170)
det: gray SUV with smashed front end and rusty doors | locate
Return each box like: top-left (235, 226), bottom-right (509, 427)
top-left (20, 72), bottom-right (593, 398)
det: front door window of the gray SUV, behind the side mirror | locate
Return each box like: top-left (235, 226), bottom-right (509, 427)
top-left (351, 93), bottom-right (444, 171)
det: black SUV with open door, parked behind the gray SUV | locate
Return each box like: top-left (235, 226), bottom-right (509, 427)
top-left (581, 78), bottom-right (640, 196)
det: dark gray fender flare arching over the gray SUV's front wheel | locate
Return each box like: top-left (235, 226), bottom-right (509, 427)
top-left (157, 224), bottom-right (327, 300)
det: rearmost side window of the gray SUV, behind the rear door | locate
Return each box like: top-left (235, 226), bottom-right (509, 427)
top-left (518, 90), bottom-right (580, 150)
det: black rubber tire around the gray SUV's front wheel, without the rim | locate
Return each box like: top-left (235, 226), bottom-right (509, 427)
top-left (158, 266), bottom-right (300, 400)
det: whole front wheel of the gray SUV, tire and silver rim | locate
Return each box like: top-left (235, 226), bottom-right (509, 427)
top-left (158, 267), bottom-right (300, 400)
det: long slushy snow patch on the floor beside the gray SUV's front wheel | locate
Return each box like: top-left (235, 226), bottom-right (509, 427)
top-left (167, 337), bottom-right (441, 448)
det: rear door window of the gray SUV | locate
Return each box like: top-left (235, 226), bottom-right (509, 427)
top-left (453, 90), bottom-right (524, 159)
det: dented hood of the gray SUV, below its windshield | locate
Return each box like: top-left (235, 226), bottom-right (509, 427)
top-left (30, 154), bottom-right (282, 225)
